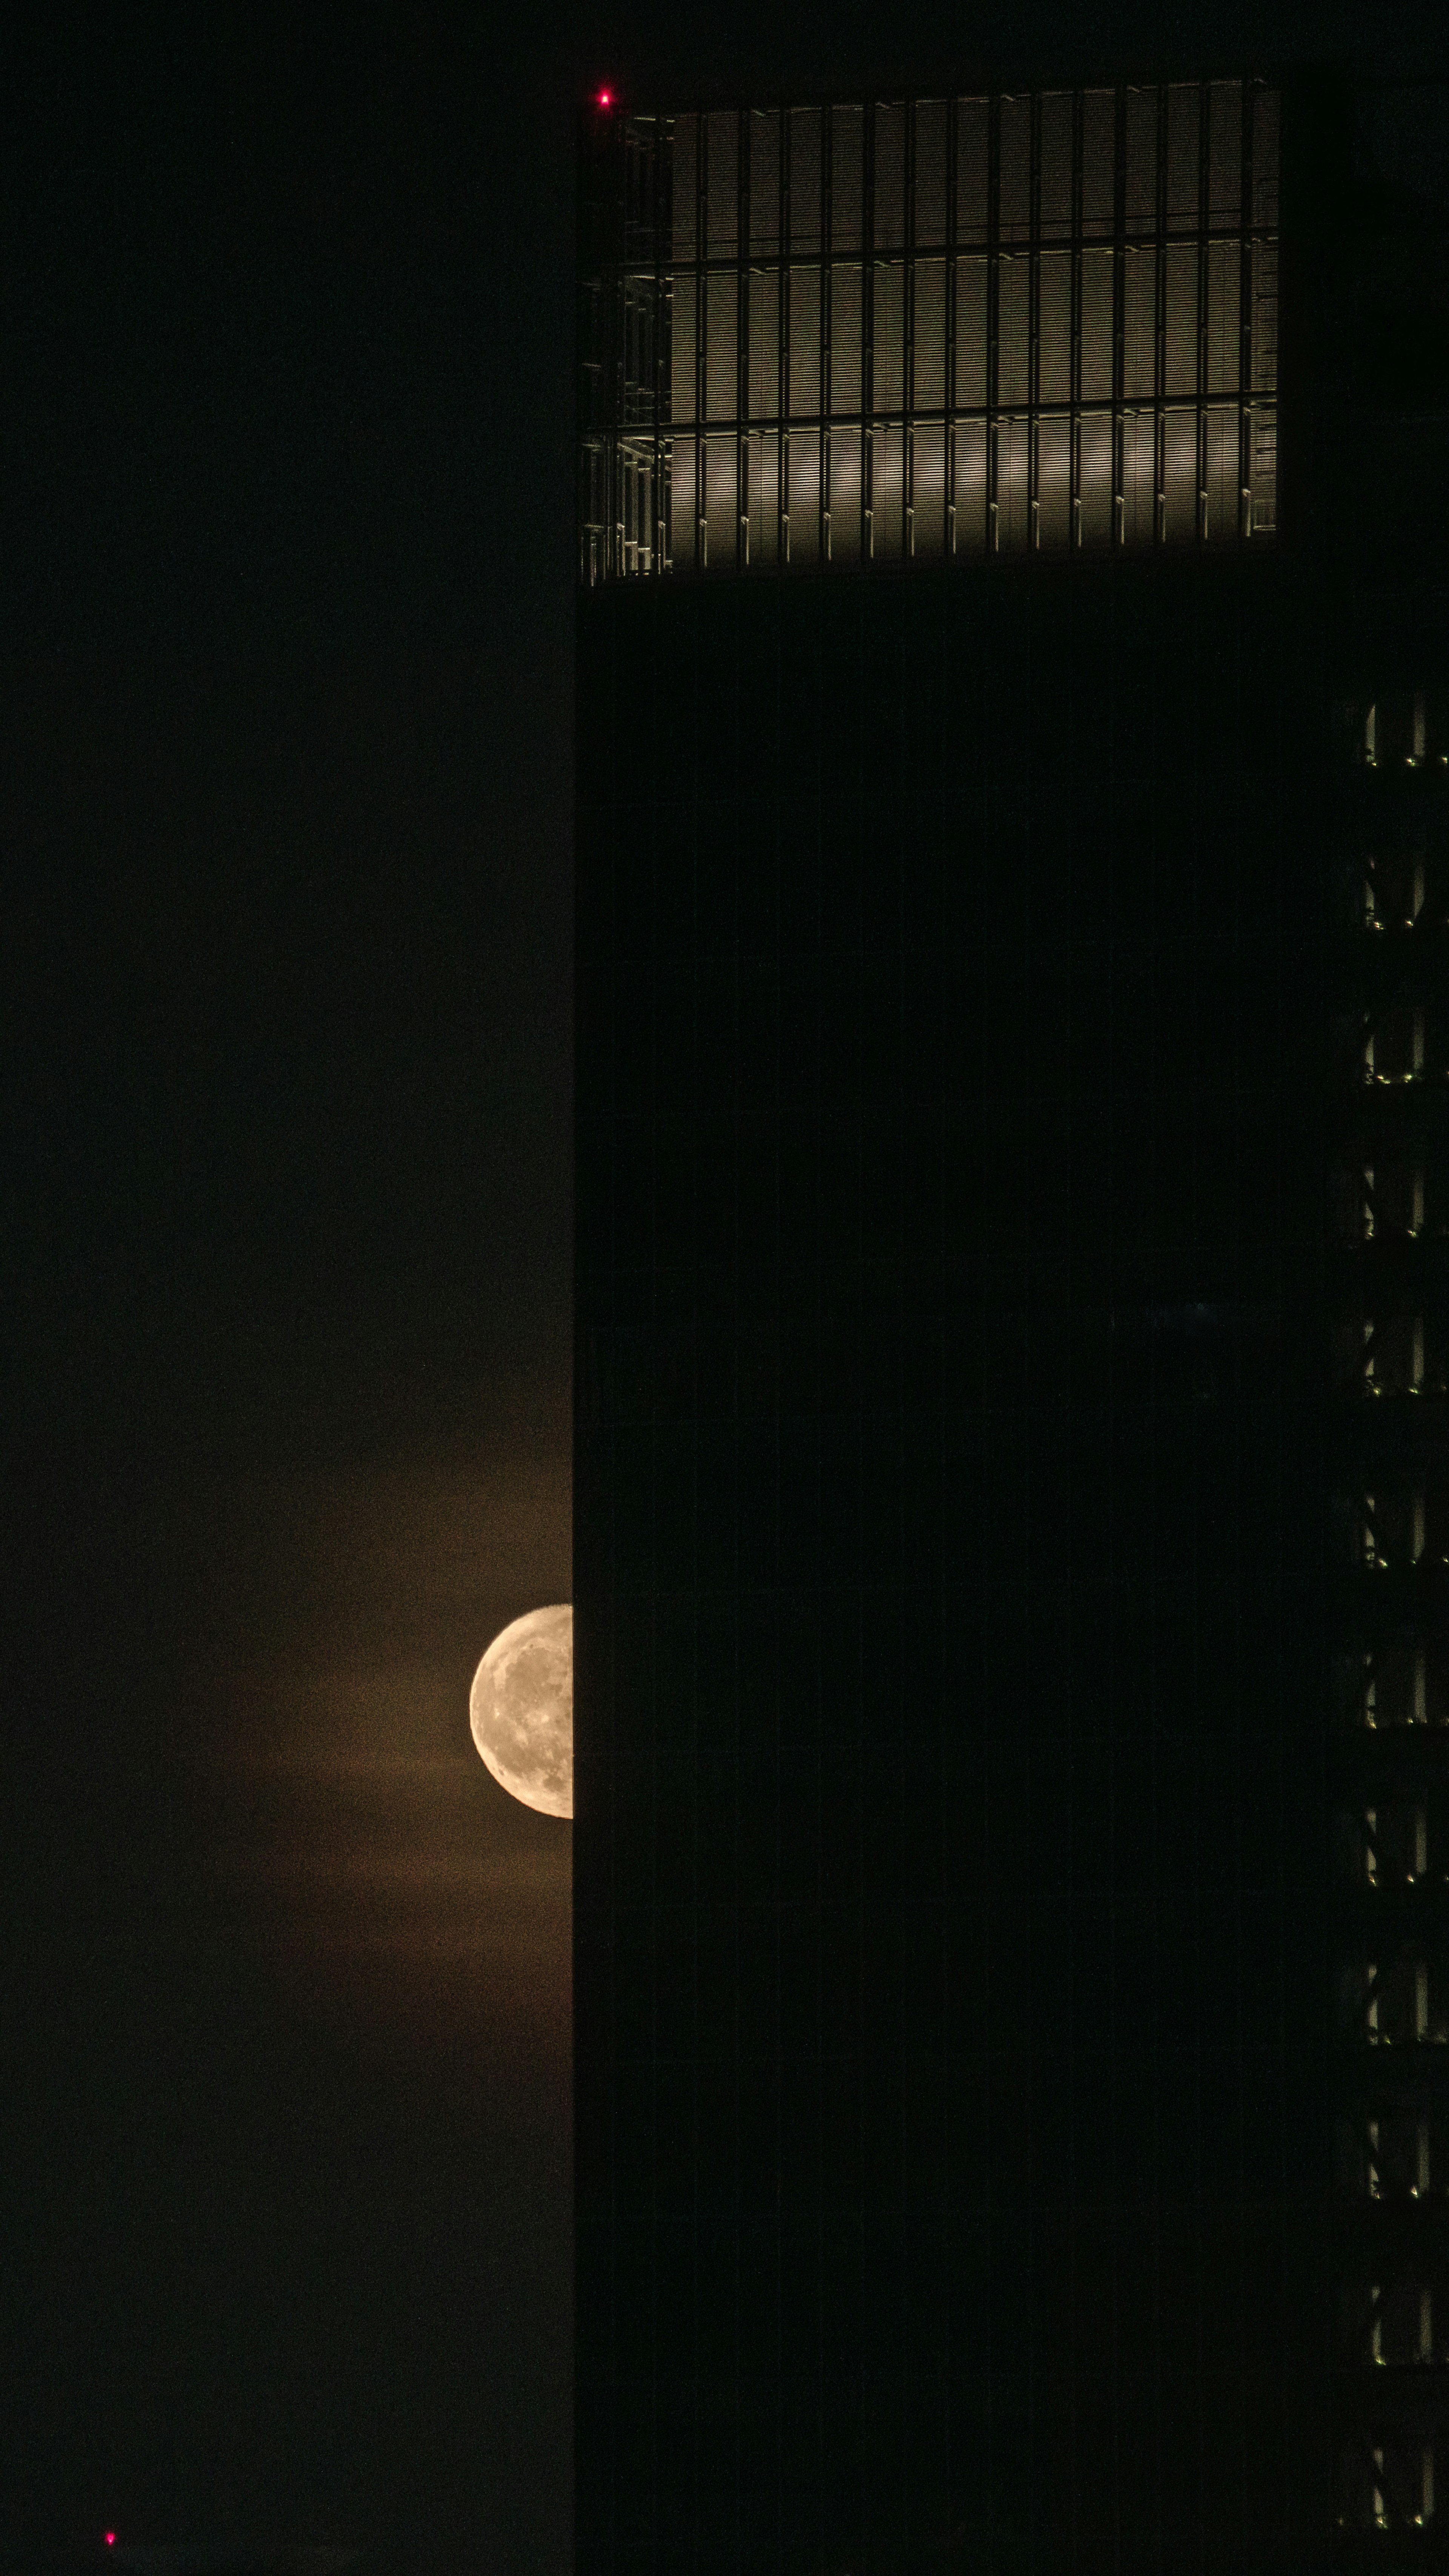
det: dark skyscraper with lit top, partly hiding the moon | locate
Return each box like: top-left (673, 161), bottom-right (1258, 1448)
top-left (574, 77), bottom-right (1449, 2576)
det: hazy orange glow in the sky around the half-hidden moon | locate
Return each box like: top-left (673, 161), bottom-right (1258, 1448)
top-left (206, 1432), bottom-right (571, 2091)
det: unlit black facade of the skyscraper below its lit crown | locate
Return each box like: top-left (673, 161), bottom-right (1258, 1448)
top-left (574, 549), bottom-right (1328, 2576)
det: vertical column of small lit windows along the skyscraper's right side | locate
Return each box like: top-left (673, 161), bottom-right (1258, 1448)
top-left (1333, 688), bottom-right (1449, 2563)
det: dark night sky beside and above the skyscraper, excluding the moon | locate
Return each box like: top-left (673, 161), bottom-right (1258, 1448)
top-left (0, 0), bottom-right (1441, 2576)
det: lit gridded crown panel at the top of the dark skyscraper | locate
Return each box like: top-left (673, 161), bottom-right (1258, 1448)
top-left (581, 80), bottom-right (1279, 582)
